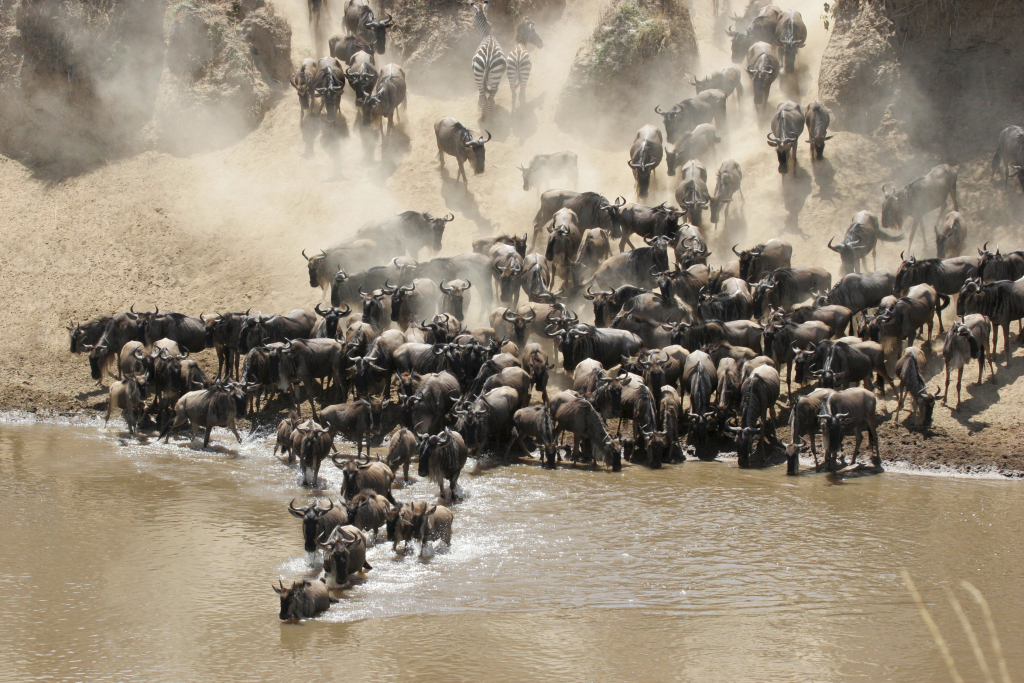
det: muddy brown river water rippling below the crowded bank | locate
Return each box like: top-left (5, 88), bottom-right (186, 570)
top-left (0, 423), bottom-right (1024, 683)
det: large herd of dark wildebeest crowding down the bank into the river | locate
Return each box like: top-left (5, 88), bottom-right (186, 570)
top-left (61, 0), bottom-right (1024, 618)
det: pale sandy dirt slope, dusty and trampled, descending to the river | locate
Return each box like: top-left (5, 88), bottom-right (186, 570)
top-left (6, 0), bottom-right (1024, 470)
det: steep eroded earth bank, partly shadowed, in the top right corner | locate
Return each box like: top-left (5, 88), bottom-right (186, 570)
top-left (819, 0), bottom-right (1024, 162)
